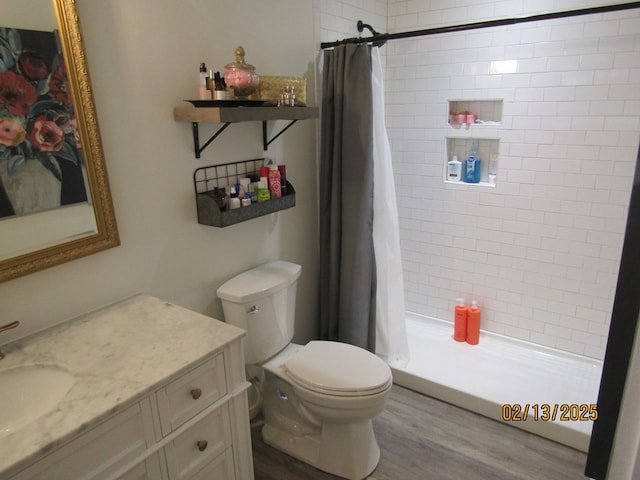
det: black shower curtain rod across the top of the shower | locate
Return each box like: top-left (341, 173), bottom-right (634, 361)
top-left (320, 2), bottom-right (640, 49)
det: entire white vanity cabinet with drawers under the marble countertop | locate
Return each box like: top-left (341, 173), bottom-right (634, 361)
top-left (5, 296), bottom-right (254, 480)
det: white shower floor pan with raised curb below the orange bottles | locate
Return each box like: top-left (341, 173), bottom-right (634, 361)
top-left (393, 312), bottom-right (602, 452)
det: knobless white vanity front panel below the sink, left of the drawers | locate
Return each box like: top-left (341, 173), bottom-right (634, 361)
top-left (12, 399), bottom-right (153, 480)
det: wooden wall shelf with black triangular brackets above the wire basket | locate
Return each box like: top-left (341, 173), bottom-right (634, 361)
top-left (173, 104), bottom-right (319, 158)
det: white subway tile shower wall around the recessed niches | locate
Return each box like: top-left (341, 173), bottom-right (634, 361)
top-left (317, 0), bottom-right (640, 359)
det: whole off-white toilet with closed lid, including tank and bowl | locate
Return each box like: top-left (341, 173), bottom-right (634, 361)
top-left (217, 261), bottom-right (393, 480)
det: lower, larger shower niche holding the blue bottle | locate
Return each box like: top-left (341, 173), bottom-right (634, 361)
top-left (444, 137), bottom-right (500, 187)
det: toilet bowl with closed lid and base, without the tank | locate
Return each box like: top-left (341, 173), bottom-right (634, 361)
top-left (262, 341), bottom-right (392, 479)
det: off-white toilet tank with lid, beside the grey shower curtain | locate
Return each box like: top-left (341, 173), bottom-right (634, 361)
top-left (217, 261), bottom-right (302, 365)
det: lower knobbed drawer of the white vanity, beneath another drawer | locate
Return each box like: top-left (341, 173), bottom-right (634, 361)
top-left (165, 404), bottom-right (233, 480)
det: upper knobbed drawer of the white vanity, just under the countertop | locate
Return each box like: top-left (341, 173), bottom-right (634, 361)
top-left (157, 353), bottom-right (227, 436)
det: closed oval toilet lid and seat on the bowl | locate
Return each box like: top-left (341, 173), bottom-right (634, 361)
top-left (284, 341), bottom-right (391, 396)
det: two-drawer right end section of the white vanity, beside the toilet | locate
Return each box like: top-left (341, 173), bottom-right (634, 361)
top-left (156, 346), bottom-right (253, 480)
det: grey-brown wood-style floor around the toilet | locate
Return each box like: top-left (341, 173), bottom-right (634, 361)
top-left (251, 385), bottom-right (586, 480)
